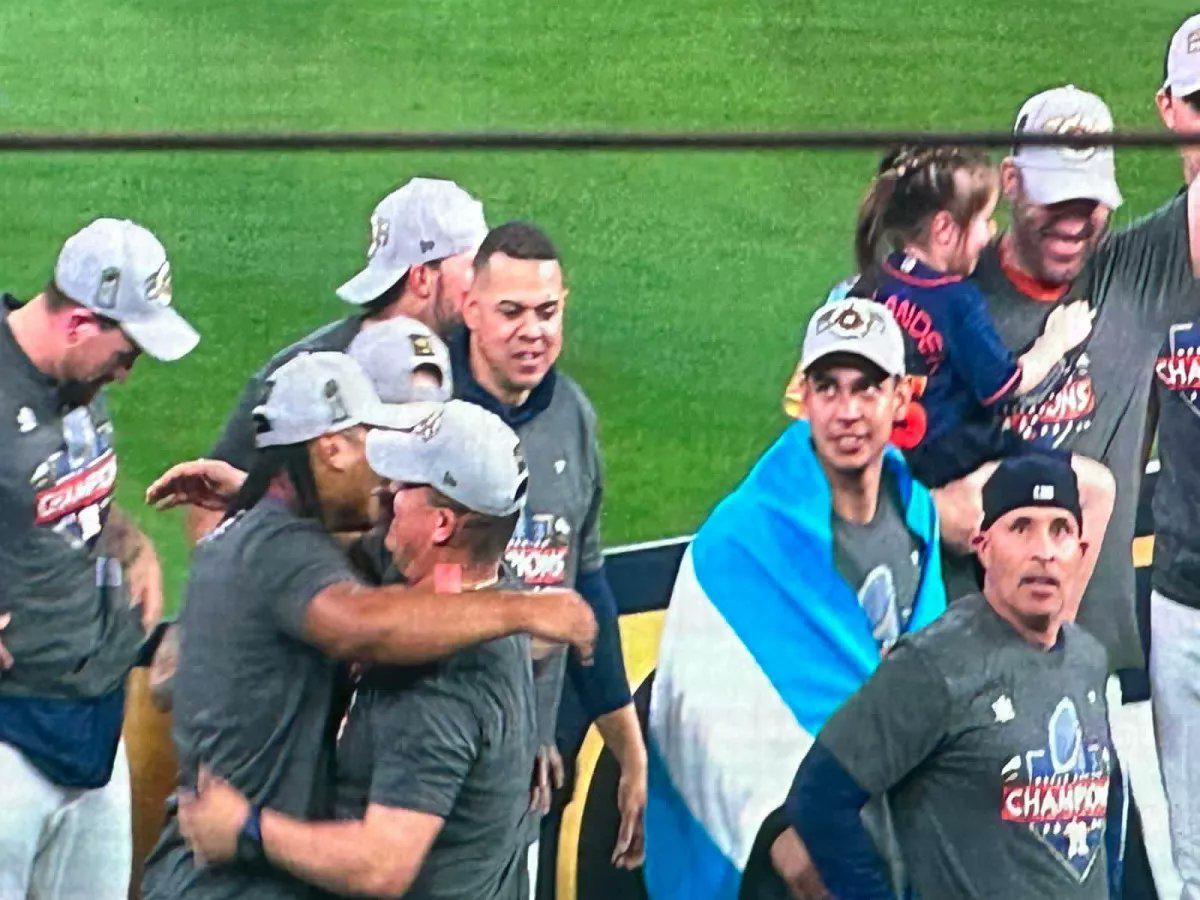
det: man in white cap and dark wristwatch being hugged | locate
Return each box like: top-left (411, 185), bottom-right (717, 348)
top-left (180, 401), bottom-right (547, 900)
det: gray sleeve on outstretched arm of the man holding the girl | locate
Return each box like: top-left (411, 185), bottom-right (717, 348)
top-left (1091, 193), bottom-right (1200, 332)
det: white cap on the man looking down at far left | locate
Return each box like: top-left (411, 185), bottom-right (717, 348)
top-left (54, 218), bottom-right (200, 362)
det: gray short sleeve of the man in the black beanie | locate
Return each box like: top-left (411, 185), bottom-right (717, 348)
top-left (817, 641), bottom-right (950, 794)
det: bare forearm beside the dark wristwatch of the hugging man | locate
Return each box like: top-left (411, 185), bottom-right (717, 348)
top-left (262, 810), bottom-right (410, 896)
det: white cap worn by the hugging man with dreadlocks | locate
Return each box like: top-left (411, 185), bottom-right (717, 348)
top-left (253, 352), bottom-right (416, 448)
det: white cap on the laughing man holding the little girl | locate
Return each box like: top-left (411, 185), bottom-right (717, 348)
top-left (1013, 84), bottom-right (1122, 209)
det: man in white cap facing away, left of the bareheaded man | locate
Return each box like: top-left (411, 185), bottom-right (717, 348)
top-left (187, 178), bottom-right (487, 541)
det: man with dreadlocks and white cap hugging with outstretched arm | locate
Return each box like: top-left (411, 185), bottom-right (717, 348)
top-left (143, 353), bottom-right (595, 900)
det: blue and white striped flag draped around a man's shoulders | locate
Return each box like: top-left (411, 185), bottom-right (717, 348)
top-left (646, 421), bottom-right (946, 900)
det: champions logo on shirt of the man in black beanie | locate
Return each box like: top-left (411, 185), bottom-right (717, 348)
top-left (1000, 697), bottom-right (1111, 882)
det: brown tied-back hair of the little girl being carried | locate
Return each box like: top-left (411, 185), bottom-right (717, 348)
top-left (854, 146), bottom-right (998, 271)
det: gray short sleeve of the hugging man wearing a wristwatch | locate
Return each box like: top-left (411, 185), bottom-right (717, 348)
top-left (368, 679), bottom-right (482, 818)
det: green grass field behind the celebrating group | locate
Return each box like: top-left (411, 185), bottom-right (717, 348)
top-left (0, 0), bottom-right (1187, 604)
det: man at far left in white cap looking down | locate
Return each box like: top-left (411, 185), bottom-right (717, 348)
top-left (0, 218), bottom-right (199, 900)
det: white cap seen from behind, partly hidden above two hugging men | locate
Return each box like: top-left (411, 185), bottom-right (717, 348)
top-left (346, 316), bottom-right (454, 403)
